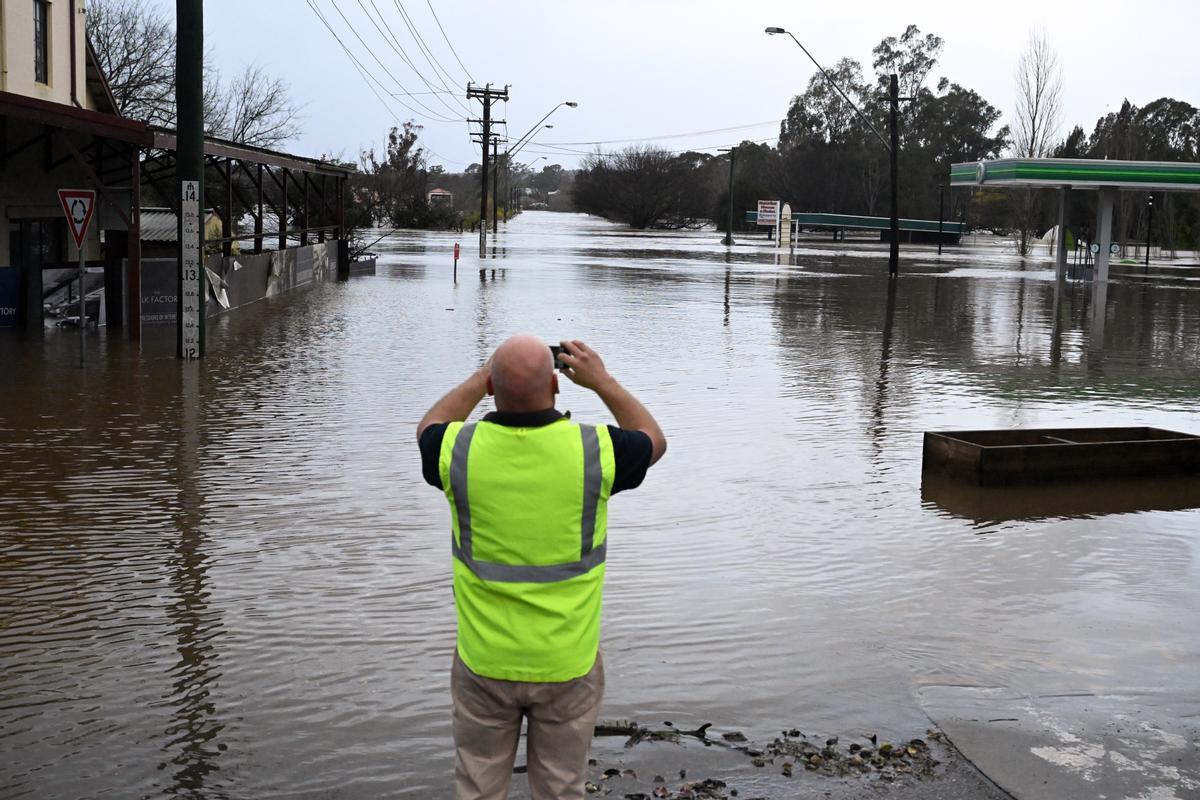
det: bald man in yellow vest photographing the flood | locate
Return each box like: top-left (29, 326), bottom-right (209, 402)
top-left (416, 336), bottom-right (667, 800)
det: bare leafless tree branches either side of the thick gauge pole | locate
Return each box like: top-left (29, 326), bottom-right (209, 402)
top-left (88, 0), bottom-right (300, 148)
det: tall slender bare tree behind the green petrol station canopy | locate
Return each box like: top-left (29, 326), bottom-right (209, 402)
top-left (1012, 30), bottom-right (1062, 255)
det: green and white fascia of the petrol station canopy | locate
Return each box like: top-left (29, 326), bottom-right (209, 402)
top-left (950, 158), bottom-right (1200, 192)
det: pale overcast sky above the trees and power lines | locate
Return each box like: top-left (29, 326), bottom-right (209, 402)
top-left (180, 0), bottom-right (1200, 172)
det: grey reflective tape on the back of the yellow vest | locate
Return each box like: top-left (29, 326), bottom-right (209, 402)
top-left (450, 422), bottom-right (608, 583)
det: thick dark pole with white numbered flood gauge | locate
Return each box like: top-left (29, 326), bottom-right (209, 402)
top-left (175, 0), bottom-right (204, 360)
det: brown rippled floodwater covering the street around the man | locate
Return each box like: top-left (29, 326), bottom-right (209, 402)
top-left (0, 212), bottom-right (1200, 799)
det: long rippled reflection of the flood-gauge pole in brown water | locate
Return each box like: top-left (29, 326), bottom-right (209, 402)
top-left (164, 365), bottom-right (224, 799)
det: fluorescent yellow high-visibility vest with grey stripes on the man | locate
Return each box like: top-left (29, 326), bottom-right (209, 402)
top-left (438, 417), bottom-right (616, 682)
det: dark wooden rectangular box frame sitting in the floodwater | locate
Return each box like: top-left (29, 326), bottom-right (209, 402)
top-left (922, 427), bottom-right (1200, 486)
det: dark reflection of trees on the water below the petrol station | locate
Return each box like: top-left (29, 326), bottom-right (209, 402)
top-left (773, 272), bottom-right (1200, 408)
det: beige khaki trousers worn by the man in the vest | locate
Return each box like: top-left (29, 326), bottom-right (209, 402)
top-left (450, 650), bottom-right (604, 800)
